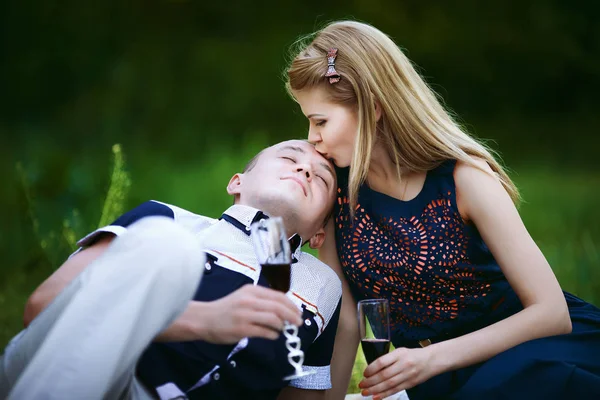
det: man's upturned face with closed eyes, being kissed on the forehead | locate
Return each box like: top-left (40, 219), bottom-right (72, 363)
top-left (228, 140), bottom-right (337, 240)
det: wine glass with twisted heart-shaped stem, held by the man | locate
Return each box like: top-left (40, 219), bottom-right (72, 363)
top-left (250, 217), bottom-right (315, 380)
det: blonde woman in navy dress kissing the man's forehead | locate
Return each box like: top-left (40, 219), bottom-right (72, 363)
top-left (287, 21), bottom-right (600, 400)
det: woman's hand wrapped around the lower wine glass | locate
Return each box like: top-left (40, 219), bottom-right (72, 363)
top-left (358, 347), bottom-right (441, 400)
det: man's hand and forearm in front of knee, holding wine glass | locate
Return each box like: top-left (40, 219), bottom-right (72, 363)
top-left (156, 285), bottom-right (302, 344)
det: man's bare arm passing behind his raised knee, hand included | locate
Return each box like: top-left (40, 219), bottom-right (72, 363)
top-left (23, 234), bottom-right (302, 343)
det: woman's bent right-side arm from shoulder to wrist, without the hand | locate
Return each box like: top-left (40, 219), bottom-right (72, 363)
top-left (424, 160), bottom-right (571, 372)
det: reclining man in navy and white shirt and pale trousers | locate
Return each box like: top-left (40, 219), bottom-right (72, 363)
top-left (0, 141), bottom-right (341, 399)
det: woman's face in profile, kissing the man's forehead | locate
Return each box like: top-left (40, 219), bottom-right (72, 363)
top-left (294, 88), bottom-right (358, 168)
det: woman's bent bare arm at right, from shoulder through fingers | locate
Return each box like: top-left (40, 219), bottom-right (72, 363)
top-left (361, 160), bottom-right (571, 397)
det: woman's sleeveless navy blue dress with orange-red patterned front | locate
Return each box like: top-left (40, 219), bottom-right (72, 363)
top-left (335, 160), bottom-right (600, 400)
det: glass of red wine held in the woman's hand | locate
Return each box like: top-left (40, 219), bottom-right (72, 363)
top-left (358, 299), bottom-right (390, 364)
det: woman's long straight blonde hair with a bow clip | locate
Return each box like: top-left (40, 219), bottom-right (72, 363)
top-left (285, 21), bottom-right (520, 211)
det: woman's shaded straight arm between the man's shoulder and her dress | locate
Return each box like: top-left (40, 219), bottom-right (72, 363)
top-left (319, 220), bottom-right (359, 400)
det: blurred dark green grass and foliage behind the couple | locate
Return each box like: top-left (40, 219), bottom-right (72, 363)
top-left (0, 0), bottom-right (600, 386)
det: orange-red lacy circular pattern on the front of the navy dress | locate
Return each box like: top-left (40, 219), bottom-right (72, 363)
top-left (336, 192), bottom-right (490, 329)
